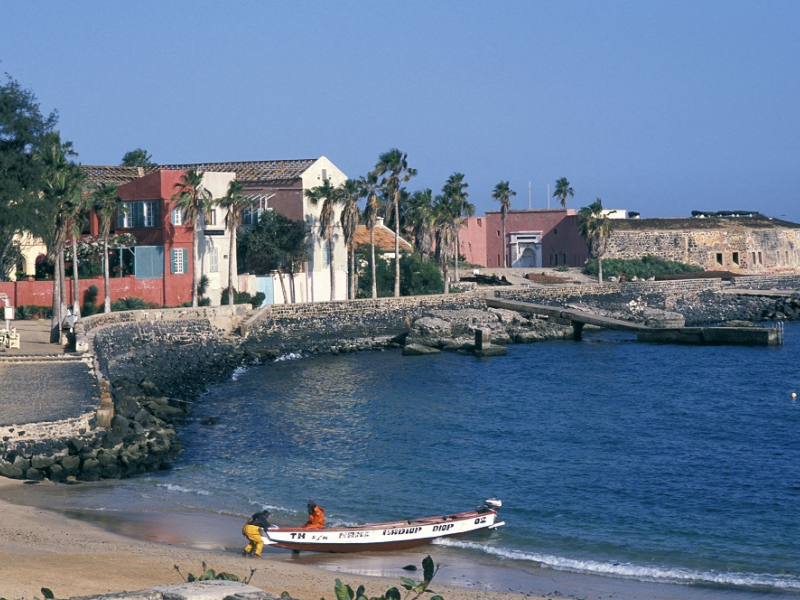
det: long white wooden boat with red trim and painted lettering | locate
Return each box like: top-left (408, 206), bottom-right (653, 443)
top-left (262, 498), bottom-right (505, 552)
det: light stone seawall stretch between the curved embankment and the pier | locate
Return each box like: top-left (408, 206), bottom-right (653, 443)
top-left (241, 294), bottom-right (486, 355)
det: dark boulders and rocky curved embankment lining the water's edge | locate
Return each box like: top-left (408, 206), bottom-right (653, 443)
top-left (0, 290), bottom-right (800, 481)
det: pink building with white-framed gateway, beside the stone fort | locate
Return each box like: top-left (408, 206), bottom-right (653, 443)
top-left (460, 209), bottom-right (589, 268)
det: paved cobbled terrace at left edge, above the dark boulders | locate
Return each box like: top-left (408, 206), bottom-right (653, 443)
top-left (0, 321), bottom-right (97, 425)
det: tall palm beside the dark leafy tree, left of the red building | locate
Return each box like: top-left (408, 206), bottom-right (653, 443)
top-left (34, 132), bottom-right (83, 343)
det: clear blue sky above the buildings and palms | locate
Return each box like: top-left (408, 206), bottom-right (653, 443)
top-left (0, 0), bottom-right (800, 222)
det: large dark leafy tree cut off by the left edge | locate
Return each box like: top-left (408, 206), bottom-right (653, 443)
top-left (0, 76), bottom-right (58, 281)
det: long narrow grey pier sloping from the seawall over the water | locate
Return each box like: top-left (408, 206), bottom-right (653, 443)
top-left (486, 297), bottom-right (783, 346)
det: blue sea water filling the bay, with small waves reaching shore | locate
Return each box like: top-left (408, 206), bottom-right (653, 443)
top-left (21, 324), bottom-right (800, 595)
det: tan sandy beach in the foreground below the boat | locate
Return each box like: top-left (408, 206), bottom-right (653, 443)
top-left (0, 479), bottom-right (533, 600)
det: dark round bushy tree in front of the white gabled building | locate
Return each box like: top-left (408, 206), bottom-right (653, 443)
top-left (238, 210), bottom-right (308, 304)
